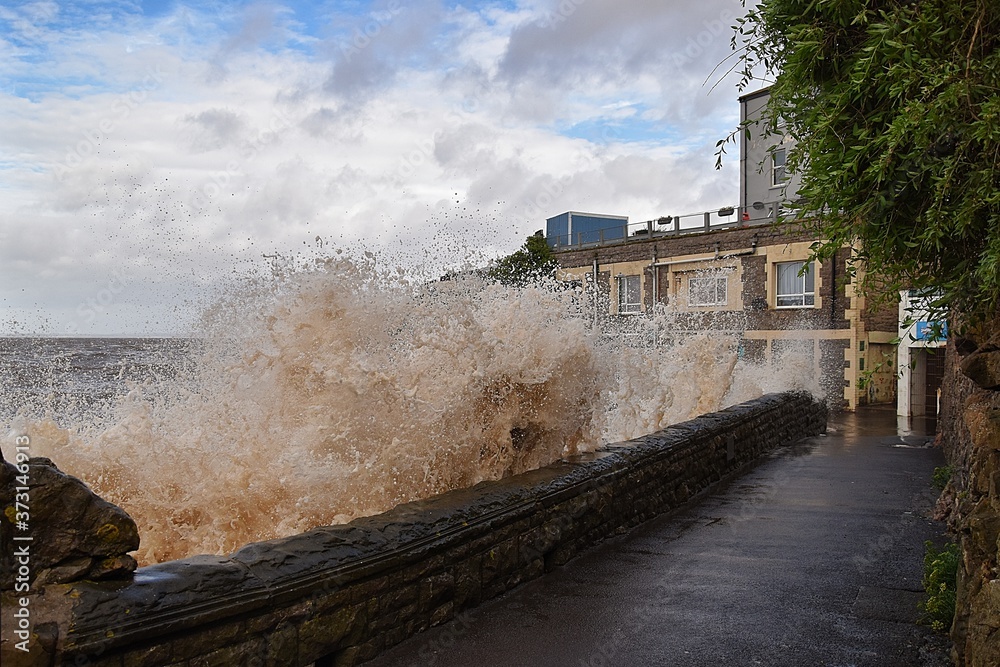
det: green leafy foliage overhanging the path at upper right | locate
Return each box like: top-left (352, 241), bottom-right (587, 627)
top-left (720, 0), bottom-right (1000, 328)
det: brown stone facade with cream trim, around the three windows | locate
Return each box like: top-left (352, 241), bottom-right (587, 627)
top-left (555, 224), bottom-right (897, 409)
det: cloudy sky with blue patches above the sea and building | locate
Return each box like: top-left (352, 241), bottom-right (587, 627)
top-left (0, 0), bottom-right (756, 335)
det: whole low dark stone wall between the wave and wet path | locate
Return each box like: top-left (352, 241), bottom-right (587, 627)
top-left (2, 393), bottom-right (826, 667)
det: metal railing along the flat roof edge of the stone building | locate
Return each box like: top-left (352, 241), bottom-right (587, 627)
top-left (547, 201), bottom-right (794, 250)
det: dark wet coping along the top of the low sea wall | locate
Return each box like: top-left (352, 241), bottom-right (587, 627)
top-left (29, 392), bottom-right (826, 655)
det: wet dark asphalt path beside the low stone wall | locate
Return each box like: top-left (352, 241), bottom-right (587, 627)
top-left (366, 410), bottom-right (943, 667)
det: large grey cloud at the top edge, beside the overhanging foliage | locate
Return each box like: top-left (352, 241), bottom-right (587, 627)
top-left (496, 0), bottom-right (743, 126)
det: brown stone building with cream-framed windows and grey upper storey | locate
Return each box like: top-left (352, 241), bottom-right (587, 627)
top-left (549, 91), bottom-right (898, 410)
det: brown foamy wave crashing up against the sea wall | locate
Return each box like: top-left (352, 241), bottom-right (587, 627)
top-left (6, 259), bottom-right (801, 563)
